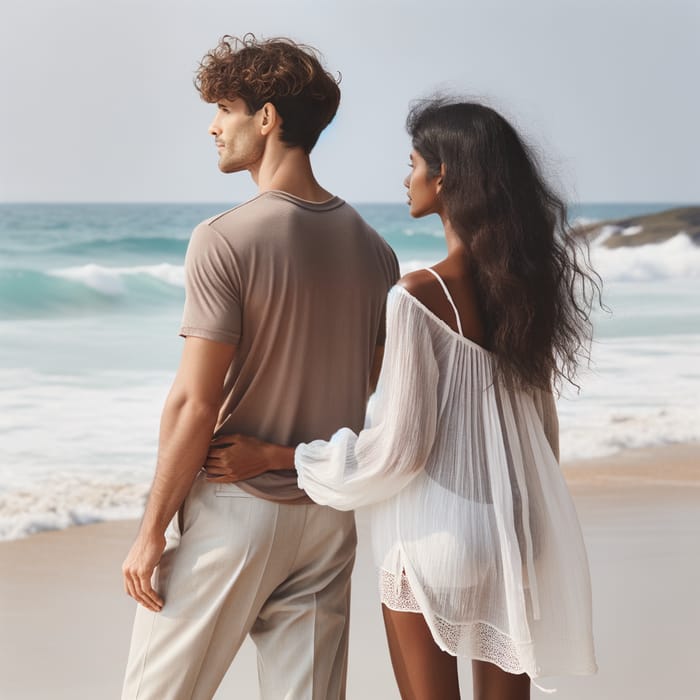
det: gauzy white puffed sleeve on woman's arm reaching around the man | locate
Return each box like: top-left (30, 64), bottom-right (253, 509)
top-left (295, 288), bottom-right (438, 510)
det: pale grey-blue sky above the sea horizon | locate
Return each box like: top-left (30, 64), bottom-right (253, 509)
top-left (0, 0), bottom-right (700, 203)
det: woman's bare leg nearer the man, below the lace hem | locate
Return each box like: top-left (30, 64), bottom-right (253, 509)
top-left (382, 605), bottom-right (459, 700)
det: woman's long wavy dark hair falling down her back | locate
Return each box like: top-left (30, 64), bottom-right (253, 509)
top-left (406, 98), bottom-right (601, 388)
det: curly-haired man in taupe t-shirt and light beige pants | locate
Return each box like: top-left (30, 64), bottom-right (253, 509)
top-left (123, 35), bottom-right (398, 700)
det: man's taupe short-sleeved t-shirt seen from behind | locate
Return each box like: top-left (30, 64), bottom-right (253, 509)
top-left (180, 191), bottom-right (399, 503)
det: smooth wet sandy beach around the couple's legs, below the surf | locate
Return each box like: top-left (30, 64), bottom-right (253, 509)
top-left (0, 444), bottom-right (700, 700)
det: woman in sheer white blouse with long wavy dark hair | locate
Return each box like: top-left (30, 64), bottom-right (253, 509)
top-left (207, 100), bottom-right (597, 700)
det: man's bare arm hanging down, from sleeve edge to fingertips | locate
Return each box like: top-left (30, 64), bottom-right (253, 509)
top-left (122, 337), bottom-right (236, 612)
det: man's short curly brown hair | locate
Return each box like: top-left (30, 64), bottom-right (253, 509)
top-left (195, 34), bottom-right (340, 153)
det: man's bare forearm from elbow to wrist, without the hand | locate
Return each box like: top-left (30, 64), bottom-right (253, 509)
top-left (141, 397), bottom-right (218, 533)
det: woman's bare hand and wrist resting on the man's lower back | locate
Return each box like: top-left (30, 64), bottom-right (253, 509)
top-left (204, 435), bottom-right (294, 483)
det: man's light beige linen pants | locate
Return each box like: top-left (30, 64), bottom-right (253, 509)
top-left (122, 476), bottom-right (356, 700)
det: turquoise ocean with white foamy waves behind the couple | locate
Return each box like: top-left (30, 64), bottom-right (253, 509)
top-left (0, 204), bottom-right (700, 539)
